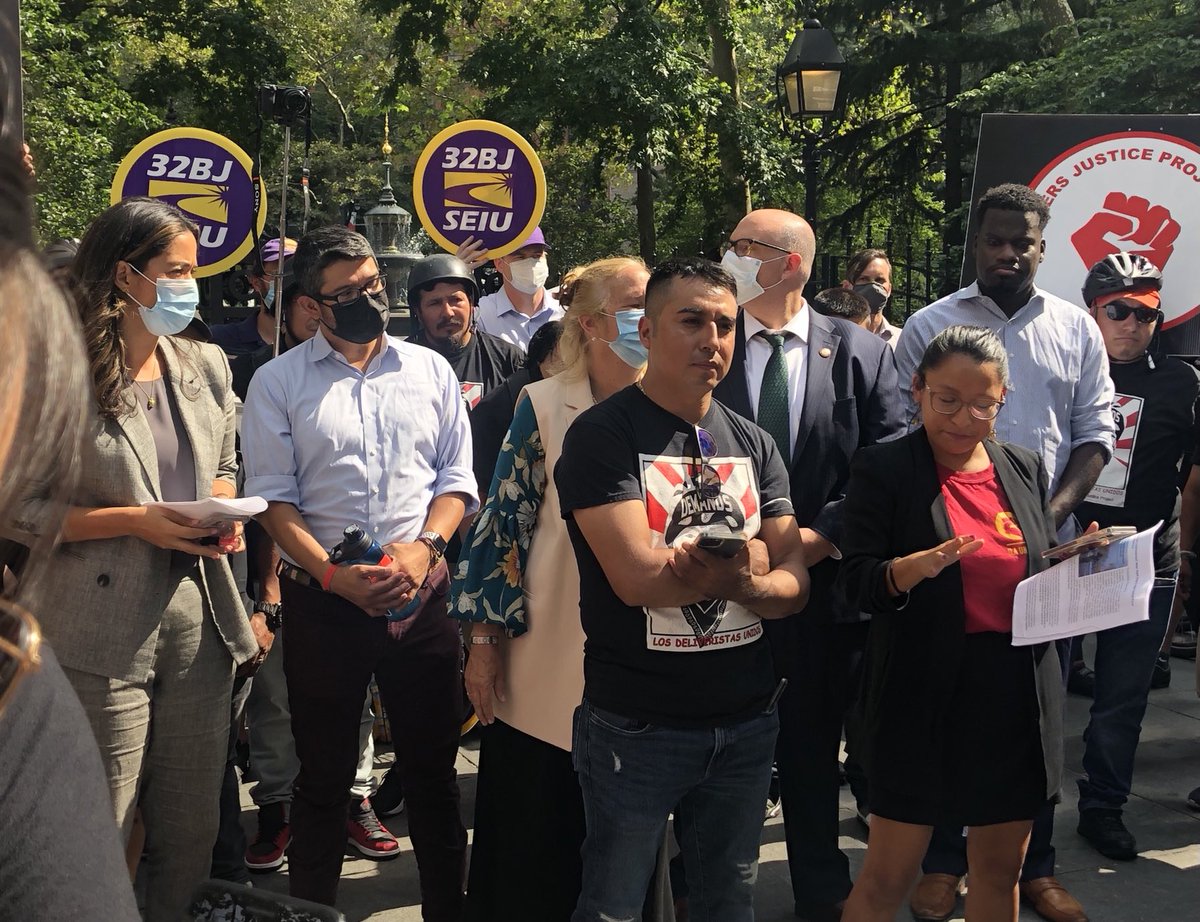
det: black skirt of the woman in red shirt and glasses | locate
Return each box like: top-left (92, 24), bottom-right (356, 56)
top-left (870, 631), bottom-right (1046, 826)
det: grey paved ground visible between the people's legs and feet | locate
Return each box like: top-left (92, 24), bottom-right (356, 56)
top-left (242, 659), bottom-right (1200, 922)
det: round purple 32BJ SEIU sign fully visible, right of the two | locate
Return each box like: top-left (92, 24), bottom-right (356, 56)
top-left (413, 119), bottom-right (546, 257)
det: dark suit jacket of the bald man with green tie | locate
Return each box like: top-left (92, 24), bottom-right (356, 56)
top-left (713, 307), bottom-right (905, 617)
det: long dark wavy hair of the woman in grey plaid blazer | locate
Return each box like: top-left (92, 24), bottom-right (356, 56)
top-left (73, 196), bottom-right (199, 419)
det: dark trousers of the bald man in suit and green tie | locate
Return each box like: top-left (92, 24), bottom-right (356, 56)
top-left (764, 611), bottom-right (870, 909)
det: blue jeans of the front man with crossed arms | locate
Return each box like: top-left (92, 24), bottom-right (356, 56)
top-left (571, 699), bottom-right (779, 922)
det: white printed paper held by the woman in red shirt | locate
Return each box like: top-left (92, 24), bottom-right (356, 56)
top-left (1013, 522), bottom-right (1162, 647)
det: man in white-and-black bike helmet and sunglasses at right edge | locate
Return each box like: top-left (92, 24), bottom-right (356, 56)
top-left (1075, 253), bottom-right (1200, 860)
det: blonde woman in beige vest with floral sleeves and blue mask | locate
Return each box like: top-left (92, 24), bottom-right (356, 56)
top-left (454, 257), bottom-right (649, 922)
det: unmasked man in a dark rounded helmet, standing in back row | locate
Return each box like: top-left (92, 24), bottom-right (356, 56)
top-left (408, 253), bottom-right (524, 409)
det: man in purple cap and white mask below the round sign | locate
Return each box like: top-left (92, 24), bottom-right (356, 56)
top-left (475, 227), bottom-right (564, 352)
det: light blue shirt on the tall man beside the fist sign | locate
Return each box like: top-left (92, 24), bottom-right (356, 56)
top-left (896, 282), bottom-right (1116, 497)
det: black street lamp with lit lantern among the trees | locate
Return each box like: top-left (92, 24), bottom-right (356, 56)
top-left (775, 19), bottom-right (846, 223)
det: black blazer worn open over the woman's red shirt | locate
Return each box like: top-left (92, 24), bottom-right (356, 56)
top-left (838, 429), bottom-right (1063, 800)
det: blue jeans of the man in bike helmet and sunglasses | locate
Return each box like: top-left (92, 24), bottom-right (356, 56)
top-left (1079, 574), bottom-right (1175, 813)
